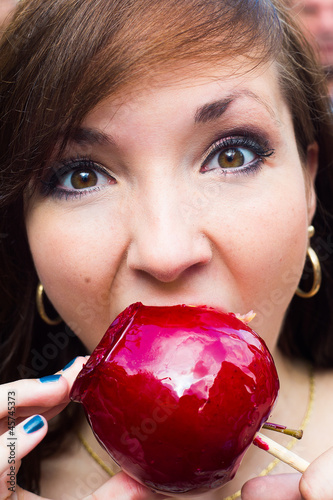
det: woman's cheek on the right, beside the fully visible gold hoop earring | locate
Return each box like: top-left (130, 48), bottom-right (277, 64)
top-left (205, 177), bottom-right (308, 349)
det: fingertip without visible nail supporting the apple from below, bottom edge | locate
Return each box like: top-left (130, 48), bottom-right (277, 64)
top-left (80, 472), bottom-right (170, 500)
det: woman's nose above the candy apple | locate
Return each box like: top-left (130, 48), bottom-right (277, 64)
top-left (127, 186), bottom-right (212, 283)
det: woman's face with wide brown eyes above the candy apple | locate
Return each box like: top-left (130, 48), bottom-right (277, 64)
top-left (26, 58), bottom-right (316, 350)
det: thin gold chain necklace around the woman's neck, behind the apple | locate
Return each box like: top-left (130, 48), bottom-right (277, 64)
top-left (78, 368), bottom-right (315, 500)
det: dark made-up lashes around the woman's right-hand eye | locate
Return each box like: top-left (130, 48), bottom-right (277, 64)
top-left (201, 132), bottom-right (275, 175)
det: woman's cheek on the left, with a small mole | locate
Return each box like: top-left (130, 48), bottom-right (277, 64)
top-left (27, 203), bottom-right (126, 349)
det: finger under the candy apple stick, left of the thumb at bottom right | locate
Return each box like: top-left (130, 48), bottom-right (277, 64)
top-left (242, 474), bottom-right (302, 500)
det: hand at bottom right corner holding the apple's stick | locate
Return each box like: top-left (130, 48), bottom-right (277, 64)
top-left (242, 448), bottom-right (333, 500)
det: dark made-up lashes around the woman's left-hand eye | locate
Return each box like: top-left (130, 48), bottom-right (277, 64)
top-left (42, 158), bottom-right (113, 200)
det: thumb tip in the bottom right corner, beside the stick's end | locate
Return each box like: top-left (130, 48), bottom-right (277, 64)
top-left (300, 448), bottom-right (333, 500)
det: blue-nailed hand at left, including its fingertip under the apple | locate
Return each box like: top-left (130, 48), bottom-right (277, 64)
top-left (0, 357), bottom-right (163, 500)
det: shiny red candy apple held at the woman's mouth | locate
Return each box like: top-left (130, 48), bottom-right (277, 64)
top-left (71, 303), bottom-right (279, 495)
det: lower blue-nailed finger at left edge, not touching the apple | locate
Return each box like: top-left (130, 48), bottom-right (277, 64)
top-left (0, 415), bottom-right (47, 474)
